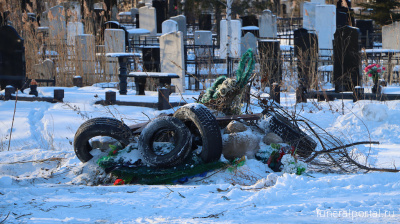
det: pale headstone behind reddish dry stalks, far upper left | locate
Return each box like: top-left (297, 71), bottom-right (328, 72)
top-left (48, 6), bottom-right (67, 44)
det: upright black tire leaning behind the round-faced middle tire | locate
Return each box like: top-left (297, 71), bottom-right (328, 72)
top-left (174, 104), bottom-right (222, 163)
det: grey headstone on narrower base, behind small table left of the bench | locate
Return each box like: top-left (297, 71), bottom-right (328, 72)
top-left (104, 29), bottom-right (126, 74)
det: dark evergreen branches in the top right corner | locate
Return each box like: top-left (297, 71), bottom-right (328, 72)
top-left (359, 0), bottom-right (400, 26)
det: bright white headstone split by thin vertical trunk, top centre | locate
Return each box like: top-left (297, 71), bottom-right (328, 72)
top-left (219, 20), bottom-right (242, 59)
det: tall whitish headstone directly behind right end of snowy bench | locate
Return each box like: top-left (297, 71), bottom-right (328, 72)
top-left (160, 31), bottom-right (185, 93)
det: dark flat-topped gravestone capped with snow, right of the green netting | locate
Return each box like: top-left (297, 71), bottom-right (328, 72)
top-left (258, 40), bottom-right (282, 88)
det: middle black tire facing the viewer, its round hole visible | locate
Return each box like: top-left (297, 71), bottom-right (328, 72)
top-left (138, 116), bottom-right (192, 168)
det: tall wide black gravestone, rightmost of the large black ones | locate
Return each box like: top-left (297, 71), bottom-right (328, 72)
top-left (333, 26), bottom-right (362, 92)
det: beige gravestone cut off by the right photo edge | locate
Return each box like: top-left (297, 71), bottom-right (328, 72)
top-left (382, 21), bottom-right (400, 50)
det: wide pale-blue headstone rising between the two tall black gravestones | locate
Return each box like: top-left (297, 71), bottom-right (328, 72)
top-left (315, 5), bottom-right (336, 56)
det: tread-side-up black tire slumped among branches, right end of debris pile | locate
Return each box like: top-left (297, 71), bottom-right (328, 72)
top-left (267, 114), bottom-right (317, 157)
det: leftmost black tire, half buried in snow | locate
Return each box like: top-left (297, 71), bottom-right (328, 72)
top-left (74, 117), bottom-right (132, 162)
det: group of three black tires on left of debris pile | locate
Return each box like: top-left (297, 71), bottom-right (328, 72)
top-left (74, 104), bottom-right (222, 168)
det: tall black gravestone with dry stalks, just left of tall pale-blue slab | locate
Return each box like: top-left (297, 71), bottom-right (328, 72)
top-left (293, 28), bottom-right (318, 89)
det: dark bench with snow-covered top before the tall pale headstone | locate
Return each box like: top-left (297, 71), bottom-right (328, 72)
top-left (128, 72), bottom-right (179, 95)
